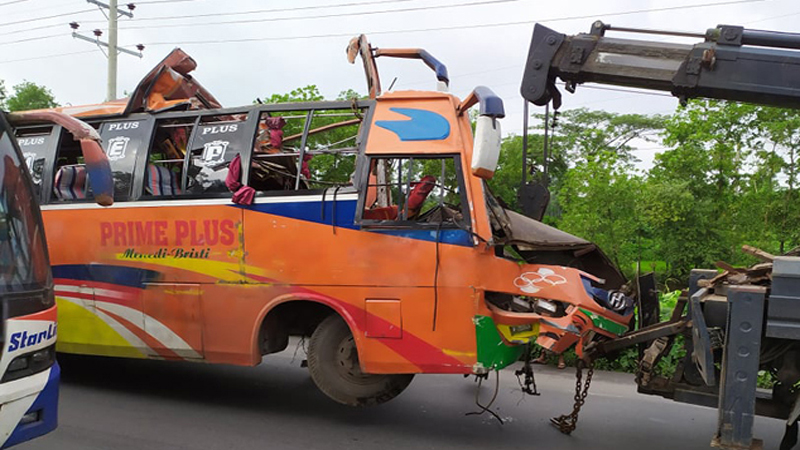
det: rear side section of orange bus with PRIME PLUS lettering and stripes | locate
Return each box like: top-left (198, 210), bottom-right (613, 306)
top-left (44, 206), bottom-right (244, 359)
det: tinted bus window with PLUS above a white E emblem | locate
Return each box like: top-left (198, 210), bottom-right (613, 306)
top-left (100, 120), bottom-right (150, 201)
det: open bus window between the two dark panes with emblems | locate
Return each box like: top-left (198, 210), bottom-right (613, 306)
top-left (144, 117), bottom-right (196, 197)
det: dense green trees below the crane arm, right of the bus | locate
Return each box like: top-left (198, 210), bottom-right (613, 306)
top-left (504, 100), bottom-right (800, 287)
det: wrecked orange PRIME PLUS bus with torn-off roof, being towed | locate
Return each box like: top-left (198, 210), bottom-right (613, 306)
top-left (16, 36), bottom-right (632, 405)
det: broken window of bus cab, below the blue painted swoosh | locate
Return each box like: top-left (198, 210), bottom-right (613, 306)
top-left (362, 156), bottom-right (469, 228)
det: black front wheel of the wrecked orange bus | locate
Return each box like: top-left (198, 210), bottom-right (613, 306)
top-left (308, 314), bottom-right (414, 406)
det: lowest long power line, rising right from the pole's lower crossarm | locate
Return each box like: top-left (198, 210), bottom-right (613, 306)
top-left (122, 0), bottom-right (771, 47)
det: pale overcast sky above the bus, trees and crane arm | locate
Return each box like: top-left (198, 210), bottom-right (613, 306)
top-left (0, 0), bottom-right (800, 167)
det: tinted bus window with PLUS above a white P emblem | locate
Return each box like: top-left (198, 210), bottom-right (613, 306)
top-left (186, 114), bottom-right (251, 194)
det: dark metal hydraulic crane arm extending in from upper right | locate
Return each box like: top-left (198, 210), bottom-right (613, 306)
top-left (521, 21), bottom-right (800, 108)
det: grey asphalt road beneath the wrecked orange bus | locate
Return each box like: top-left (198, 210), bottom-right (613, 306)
top-left (17, 344), bottom-right (783, 450)
